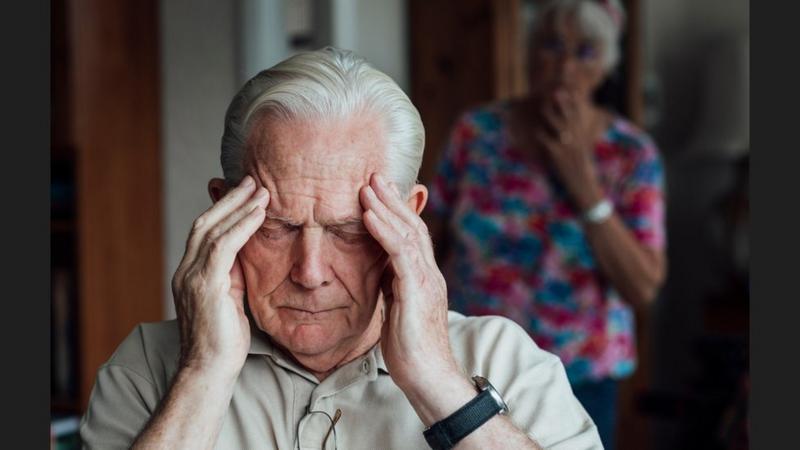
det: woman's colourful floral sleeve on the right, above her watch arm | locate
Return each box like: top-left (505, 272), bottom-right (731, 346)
top-left (615, 135), bottom-right (666, 250)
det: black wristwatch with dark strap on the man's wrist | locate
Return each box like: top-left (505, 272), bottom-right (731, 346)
top-left (423, 375), bottom-right (508, 450)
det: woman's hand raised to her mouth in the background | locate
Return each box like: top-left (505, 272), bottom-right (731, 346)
top-left (534, 91), bottom-right (604, 212)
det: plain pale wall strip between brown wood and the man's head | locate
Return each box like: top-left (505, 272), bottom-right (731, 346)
top-left (161, 0), bottom-right (238, 318)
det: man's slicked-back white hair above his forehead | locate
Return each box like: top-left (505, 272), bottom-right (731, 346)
top-left (220, 47), bottom-right (425, 193)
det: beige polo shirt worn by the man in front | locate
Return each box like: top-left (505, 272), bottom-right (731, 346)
top-left (80, 311), bottom-right (602, 450)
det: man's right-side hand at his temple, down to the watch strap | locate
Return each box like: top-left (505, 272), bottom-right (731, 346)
top-left (360, 175), bottom-right (466, 421)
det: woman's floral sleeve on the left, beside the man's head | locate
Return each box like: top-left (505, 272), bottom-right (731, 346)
top-left (428, 113), bottom-right (475, 217)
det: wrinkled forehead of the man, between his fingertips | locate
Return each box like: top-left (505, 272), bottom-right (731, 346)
top-left (246, 117), bottom-right (385, 221)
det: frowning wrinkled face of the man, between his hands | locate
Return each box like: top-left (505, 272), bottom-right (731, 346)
top-left (239, 113), bottom-right (386, 371)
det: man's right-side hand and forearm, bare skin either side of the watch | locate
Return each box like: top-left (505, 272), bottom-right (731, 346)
top-left (360, 174), bottom-right (539, 449)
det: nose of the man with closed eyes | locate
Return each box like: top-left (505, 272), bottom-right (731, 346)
top-left (291, 228), bottom-right (333, 289)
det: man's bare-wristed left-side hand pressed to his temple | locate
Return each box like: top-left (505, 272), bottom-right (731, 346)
top-left (172, 176), bottom-right (269, 378)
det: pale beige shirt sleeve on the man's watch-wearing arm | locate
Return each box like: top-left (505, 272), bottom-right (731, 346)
top-left (456, 316), bottom-right (603, 450)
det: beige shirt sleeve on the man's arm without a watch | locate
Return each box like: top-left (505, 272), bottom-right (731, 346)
top-left (80, 328), bottom-right (160, 450)
